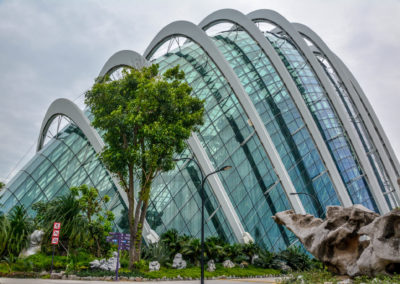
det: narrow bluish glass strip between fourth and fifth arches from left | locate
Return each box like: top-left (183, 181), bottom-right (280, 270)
top-left (265, 32), bottom-right (378, 212)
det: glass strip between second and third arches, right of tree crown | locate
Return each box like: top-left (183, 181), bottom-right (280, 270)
top-left (156, 43), bottom-right (290, 248)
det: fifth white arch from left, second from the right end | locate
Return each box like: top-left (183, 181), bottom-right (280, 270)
top-left (247, 9), bottom-right (389, 214)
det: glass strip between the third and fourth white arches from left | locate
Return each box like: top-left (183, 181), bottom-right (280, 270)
top-left (215, 31), bottom-right (340, 216)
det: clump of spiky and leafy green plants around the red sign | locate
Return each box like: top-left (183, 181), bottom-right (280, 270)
top-left (32, 185), bottom-right (114, 257)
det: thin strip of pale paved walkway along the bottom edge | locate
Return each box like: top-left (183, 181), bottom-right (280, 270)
top-left (0, 277), bottom-right (279, 284)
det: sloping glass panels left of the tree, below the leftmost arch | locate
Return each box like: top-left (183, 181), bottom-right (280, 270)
top-left (1, 123), bottom-right (126, 229)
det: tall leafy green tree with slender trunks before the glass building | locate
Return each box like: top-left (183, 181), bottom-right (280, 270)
top-left (85, 65), bottom-right (204, 268)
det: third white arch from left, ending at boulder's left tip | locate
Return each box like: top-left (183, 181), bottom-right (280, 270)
top-left (144, 21), bottom-right (305, 220)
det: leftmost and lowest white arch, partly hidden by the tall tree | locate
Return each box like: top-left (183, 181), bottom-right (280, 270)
top-left (37, 98), bottom-right (159, 243)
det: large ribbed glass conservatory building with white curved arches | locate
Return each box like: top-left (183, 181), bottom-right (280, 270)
top-left (1, 9), bottom-right (400, 249)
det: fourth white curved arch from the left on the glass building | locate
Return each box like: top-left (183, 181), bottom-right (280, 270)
top-left (199, 9), bottom-right (352, 207)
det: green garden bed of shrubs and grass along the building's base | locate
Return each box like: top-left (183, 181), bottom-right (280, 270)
top-left (0, 196), bottom-right (400, 283)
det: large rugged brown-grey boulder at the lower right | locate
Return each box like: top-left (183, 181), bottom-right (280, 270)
top-left (272, 205), bottom-right (400, 277)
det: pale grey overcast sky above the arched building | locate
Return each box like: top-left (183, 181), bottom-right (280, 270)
top-left (0, 0), bottom-right (400, 180)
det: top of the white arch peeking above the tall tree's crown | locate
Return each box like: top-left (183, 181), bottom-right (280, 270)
top-left (99, 50), bottom-right (150, 77)
